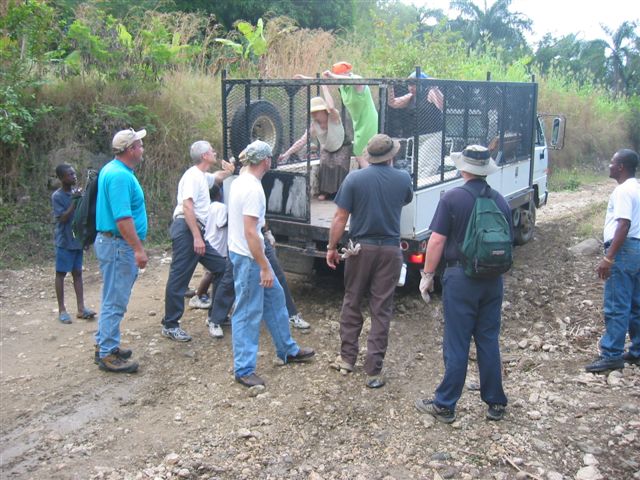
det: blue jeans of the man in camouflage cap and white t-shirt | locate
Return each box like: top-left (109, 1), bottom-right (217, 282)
top-left (229, 252), bottom-right (300, 378)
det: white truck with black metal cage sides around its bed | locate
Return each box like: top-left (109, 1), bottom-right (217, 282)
top-left (222, 67), bottom-right (566, 275)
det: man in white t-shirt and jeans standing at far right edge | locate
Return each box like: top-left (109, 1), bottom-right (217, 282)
top-left (585, 149), bottom-right (640, 373)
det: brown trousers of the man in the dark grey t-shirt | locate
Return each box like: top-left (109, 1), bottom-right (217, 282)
top-left (340, 244), bottom-right (402, 375)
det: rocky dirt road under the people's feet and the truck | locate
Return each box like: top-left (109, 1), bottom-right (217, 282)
top-left (0, 181), bottom-right (640, 480)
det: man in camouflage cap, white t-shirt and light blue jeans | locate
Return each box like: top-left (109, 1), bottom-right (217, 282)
top-left (228, 140), bottom-right (315, 387)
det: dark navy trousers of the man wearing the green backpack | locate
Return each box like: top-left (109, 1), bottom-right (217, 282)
top-left (434, 267), bottom-right (507, 410)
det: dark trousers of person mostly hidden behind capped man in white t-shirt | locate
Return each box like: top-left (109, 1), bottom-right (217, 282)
top-left (209, 240), bottom-right (298, 325)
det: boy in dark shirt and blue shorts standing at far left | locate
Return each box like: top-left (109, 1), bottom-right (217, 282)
top-left (51, 163), bottom-right (96, 323)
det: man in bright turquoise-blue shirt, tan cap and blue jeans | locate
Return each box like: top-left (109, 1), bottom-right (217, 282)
top-left (94, 128), bottom-right (148, 373)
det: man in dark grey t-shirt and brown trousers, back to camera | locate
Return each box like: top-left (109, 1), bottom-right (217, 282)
top-left (327, 134), bottom-right (413, 388)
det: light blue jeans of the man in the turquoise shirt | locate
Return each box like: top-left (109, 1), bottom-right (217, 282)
top-left (93, 233), bottom-right (138, 358)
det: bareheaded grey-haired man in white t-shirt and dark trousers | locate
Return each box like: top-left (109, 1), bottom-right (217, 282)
top-left (162, 140), bottom-right (233, 342)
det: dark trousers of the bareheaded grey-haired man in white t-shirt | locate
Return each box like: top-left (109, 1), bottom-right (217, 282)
top-left (162, 218), bottom-right (226, 328)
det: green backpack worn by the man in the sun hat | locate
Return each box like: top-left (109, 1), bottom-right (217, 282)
top-left (458, 185), bottom-right (513, 278)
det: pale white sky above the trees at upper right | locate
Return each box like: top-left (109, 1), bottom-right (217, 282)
top-left (403, 0), bottom-right (640, 42)
